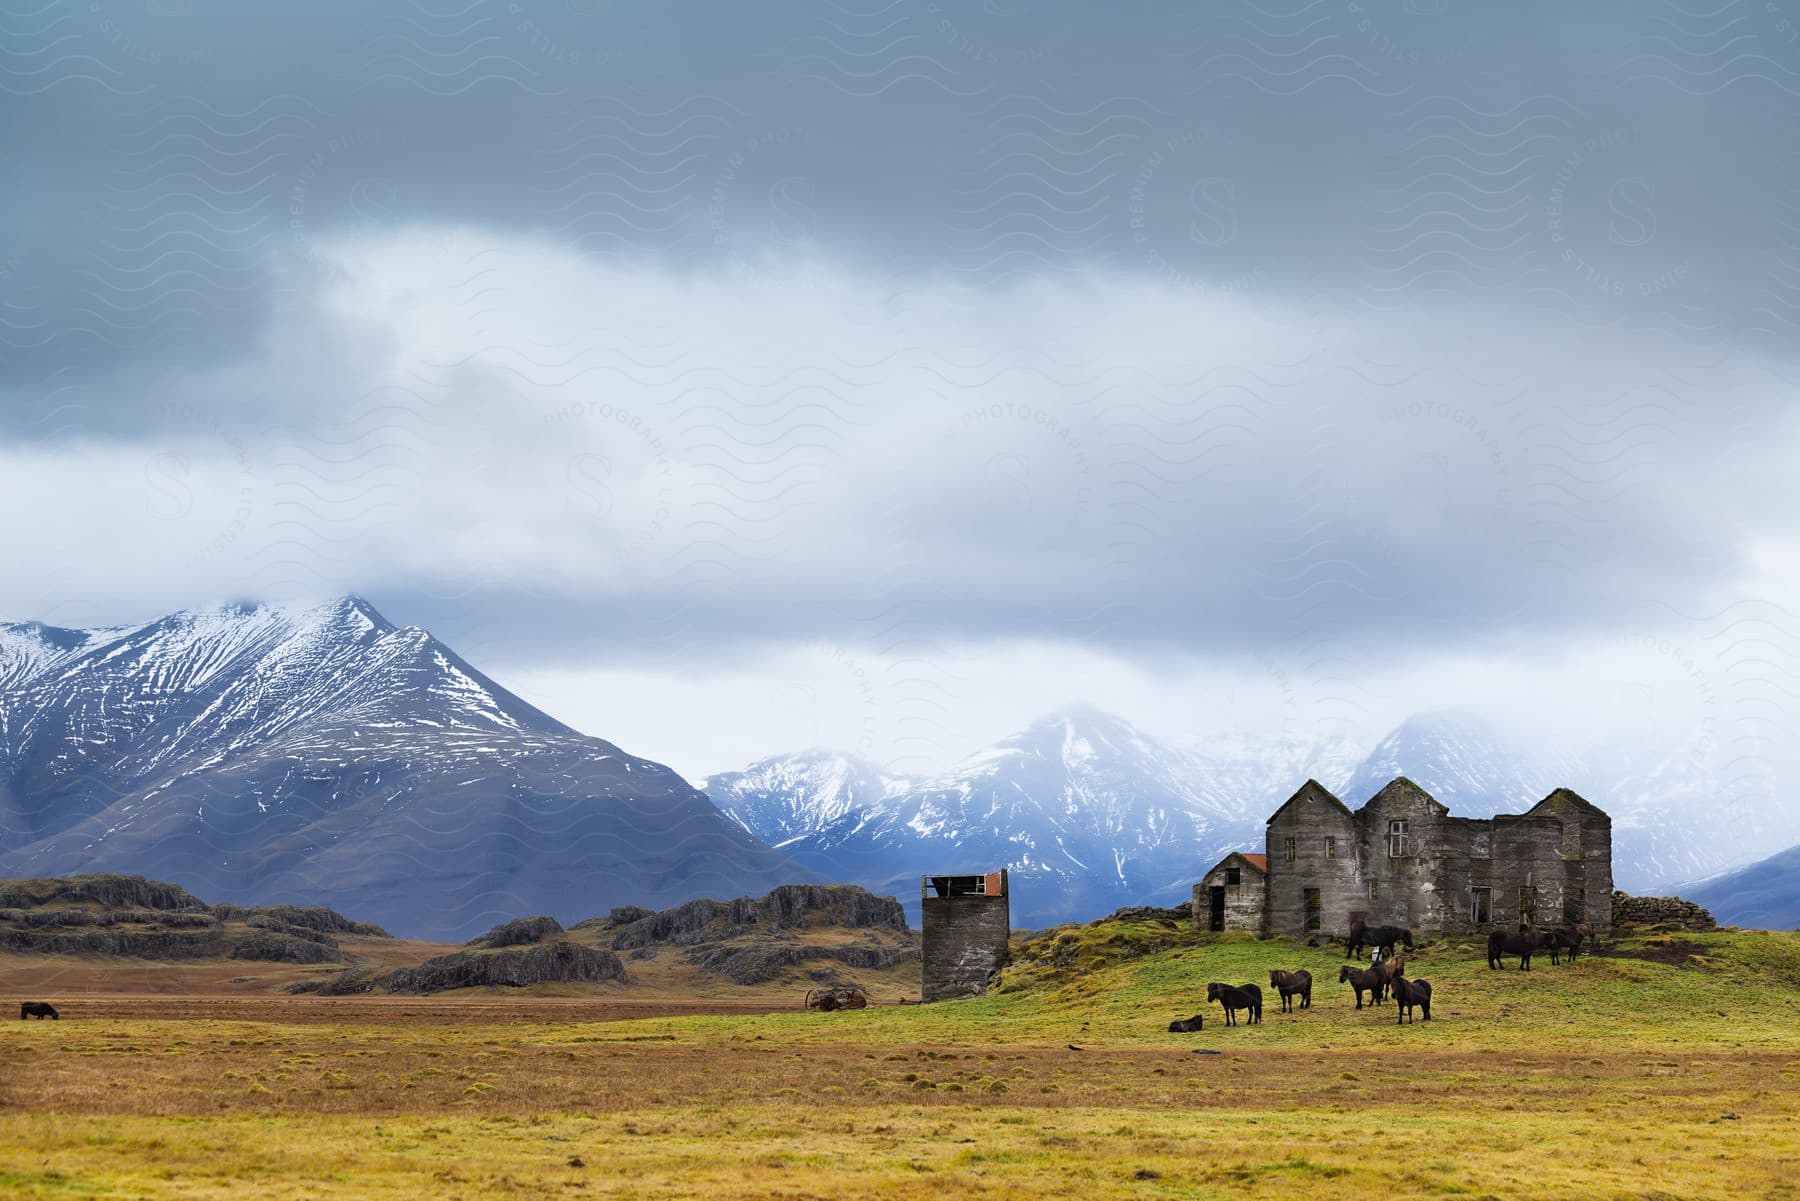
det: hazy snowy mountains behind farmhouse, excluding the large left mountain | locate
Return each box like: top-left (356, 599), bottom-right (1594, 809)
top-left (702, 708), bottom-right (1778, 926)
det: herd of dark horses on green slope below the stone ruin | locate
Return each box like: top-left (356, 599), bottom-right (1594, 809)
top-left (1168, 922), bottom-right (1593, 1034)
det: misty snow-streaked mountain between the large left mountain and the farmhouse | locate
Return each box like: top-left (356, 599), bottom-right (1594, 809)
top-left (707, 708), bottom-right (1348, 926)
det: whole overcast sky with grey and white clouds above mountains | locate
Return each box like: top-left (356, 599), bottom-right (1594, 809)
top-left (0, 0), bottom-right (1800, 796)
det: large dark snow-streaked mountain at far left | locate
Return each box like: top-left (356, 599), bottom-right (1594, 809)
top-left (0, 598), bottom-right (805, 938)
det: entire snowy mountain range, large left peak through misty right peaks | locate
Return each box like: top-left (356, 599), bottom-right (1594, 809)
top-left (10, 596), bottom-right (1800, 940)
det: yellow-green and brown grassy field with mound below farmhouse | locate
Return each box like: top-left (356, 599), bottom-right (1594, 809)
top-left (0, 920), bottom-right (1800, 1201)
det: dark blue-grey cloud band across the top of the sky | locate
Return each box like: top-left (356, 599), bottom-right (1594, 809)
top-left (0, 0), bottom-right (1800, 438)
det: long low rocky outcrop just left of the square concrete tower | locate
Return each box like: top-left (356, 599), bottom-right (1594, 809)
top-left (604, 884), bottom-right (907, 951)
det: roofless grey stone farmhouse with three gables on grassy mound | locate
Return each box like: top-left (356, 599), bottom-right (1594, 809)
top-left (1193, 776), bottom-right (1613, 936)
